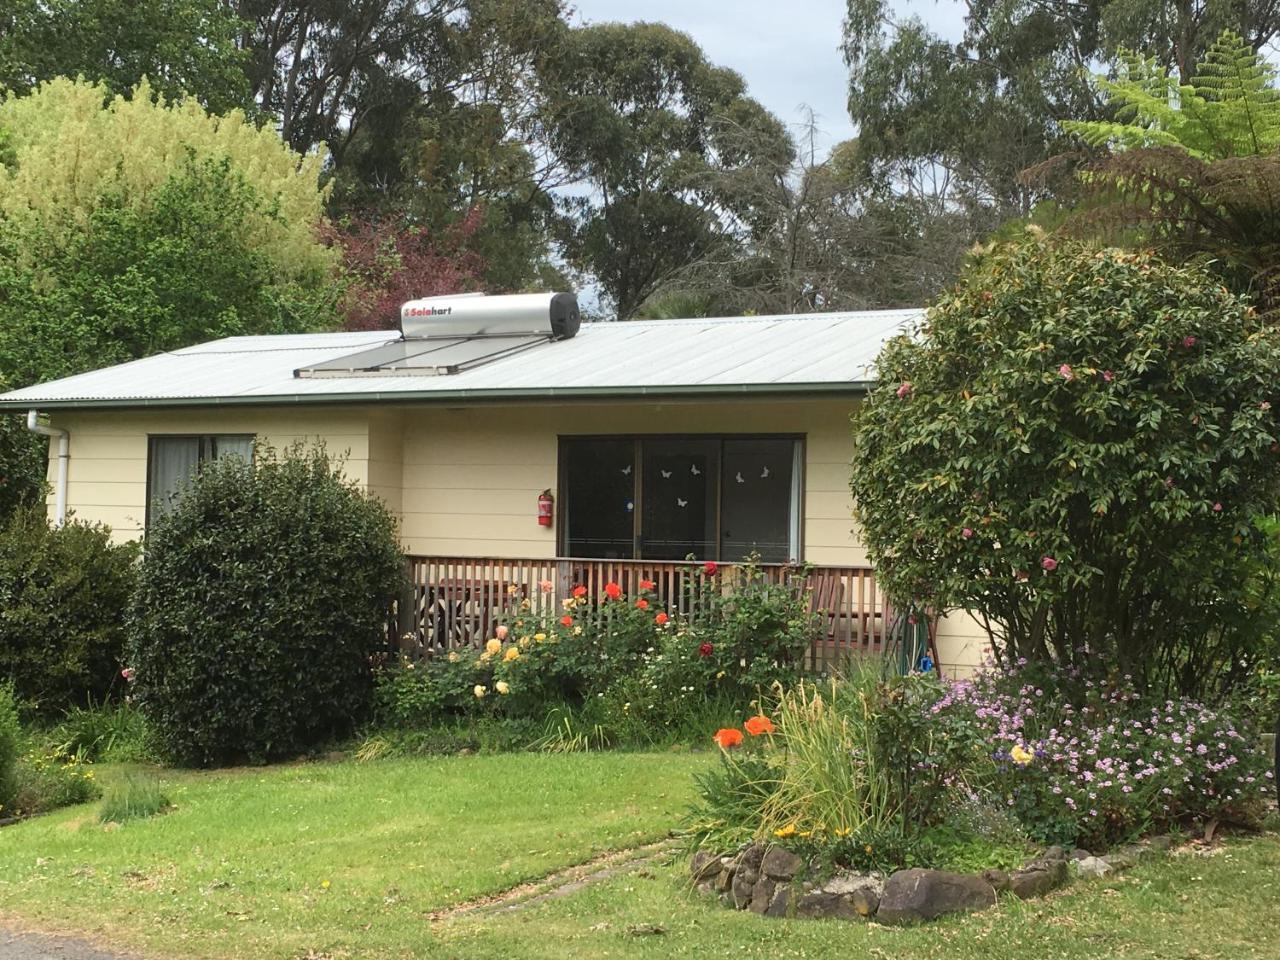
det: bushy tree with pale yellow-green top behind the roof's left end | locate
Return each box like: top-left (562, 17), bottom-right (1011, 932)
top-left (0, 79), bottom-right (338, 387)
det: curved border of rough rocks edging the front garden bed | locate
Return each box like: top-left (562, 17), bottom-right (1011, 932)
top-left (690, 836), bottom-right (1174, 924)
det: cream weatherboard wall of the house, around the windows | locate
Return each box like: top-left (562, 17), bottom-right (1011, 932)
top-left (37, 397), bottom-right (987, 672)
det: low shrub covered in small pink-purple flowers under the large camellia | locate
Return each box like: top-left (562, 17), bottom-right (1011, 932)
top-left (929, 662), bottom-right (1274, 849)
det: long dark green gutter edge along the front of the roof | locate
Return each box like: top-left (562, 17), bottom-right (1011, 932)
top-left (0, 380), bottom-right (876, 411)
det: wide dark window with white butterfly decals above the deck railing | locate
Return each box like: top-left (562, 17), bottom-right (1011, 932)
top-left (561, 436), bottom-right (801, 563)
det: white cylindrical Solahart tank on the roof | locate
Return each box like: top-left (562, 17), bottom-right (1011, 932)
top-left (401, 293), bottom-right (581, 340)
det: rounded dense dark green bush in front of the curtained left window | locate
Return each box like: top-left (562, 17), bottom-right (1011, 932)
top-left (127, 447), bottom-right (404, 765)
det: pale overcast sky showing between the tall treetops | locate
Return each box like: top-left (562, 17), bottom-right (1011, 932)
top-left (573, 0), bottom-right (961, 156)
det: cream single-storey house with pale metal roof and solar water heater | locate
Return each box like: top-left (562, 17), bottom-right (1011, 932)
top-left (0, 294), bottom-right (987, 672)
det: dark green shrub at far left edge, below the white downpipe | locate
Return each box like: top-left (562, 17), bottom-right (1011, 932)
top-left (0, 504), bottom-right (138, 712)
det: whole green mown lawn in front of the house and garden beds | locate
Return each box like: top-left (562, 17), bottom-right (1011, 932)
top-left (0, 754), bottom-right (1280, 960)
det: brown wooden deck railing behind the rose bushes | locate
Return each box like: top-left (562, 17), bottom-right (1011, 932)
top-left (398, 556), bottom-right (892, 666)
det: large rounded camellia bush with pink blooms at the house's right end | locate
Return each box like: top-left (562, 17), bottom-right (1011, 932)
top-left (852, 236), bottom-right (1280, 695)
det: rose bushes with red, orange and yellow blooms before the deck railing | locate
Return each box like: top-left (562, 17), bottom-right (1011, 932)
top-left (376, 563), bottom-right (812, 740)
